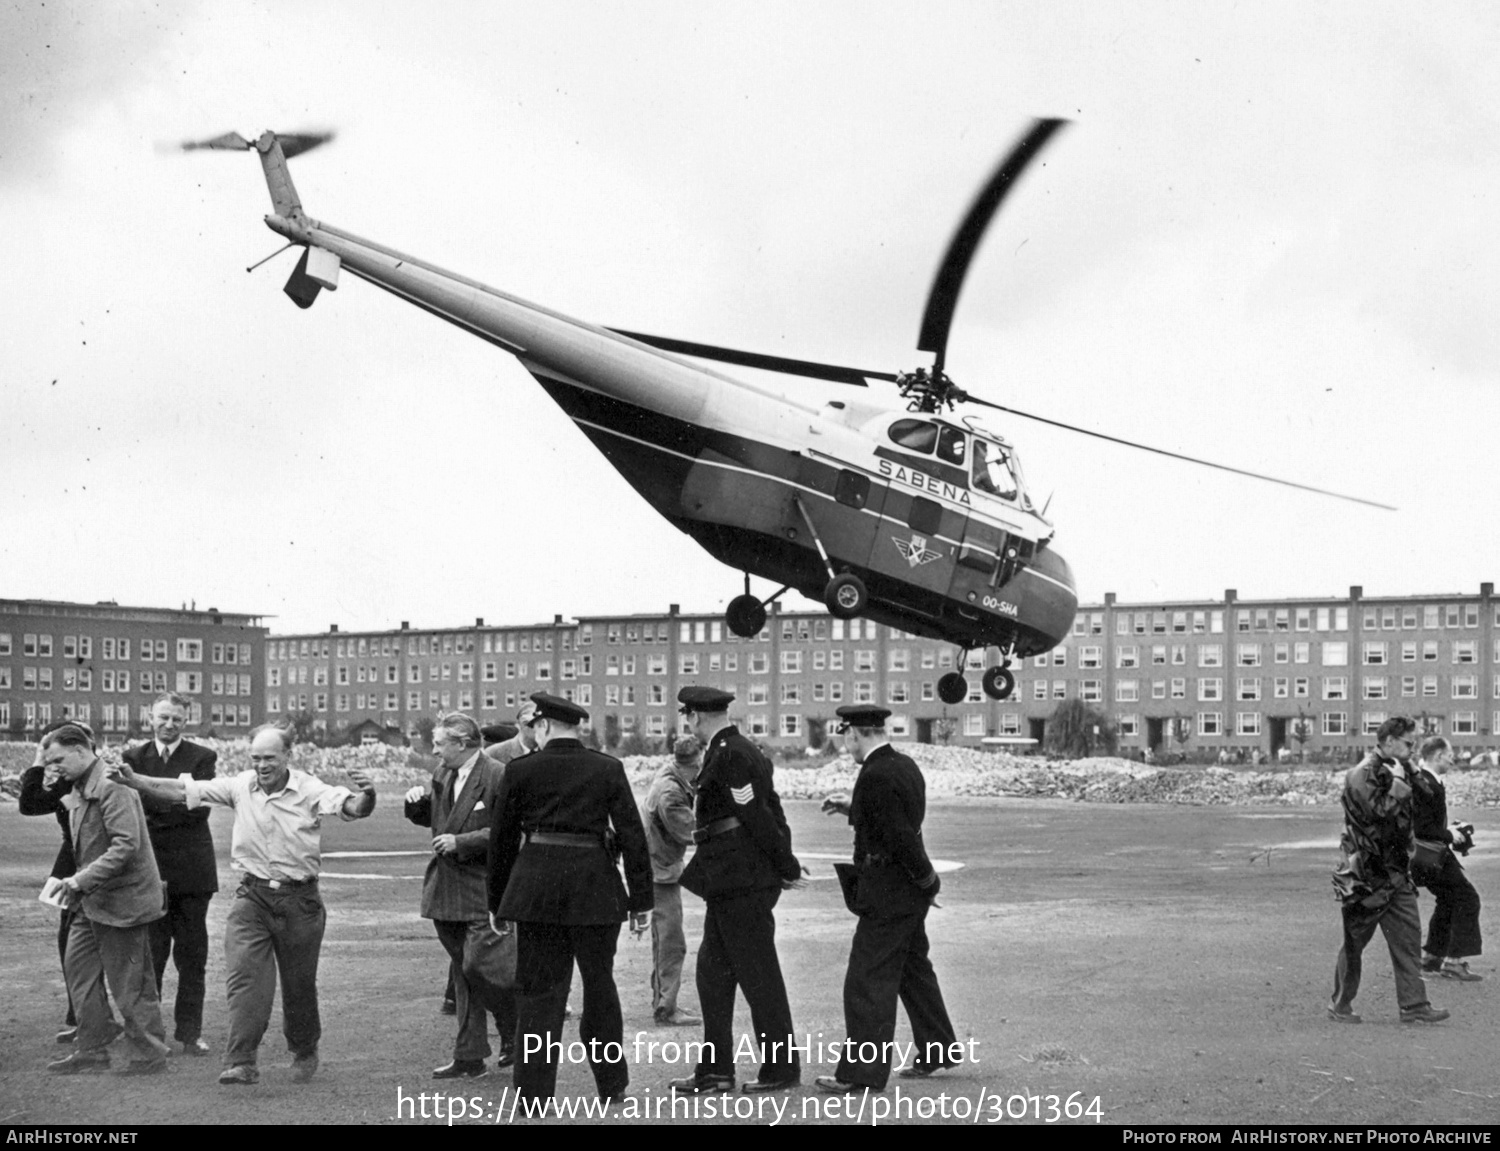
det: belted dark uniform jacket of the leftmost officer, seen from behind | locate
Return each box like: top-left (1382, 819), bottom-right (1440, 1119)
top-left (489, 738), bottom-right (653, 926)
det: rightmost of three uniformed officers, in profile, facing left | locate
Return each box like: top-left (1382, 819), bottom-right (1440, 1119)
top-left (816, 704), bottom-right (962, 1094)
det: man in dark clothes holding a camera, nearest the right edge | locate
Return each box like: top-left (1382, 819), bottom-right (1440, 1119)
top-left (1412, 735), bottom-right (1484, 983)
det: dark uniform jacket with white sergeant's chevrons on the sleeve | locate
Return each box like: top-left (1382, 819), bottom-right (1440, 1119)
top-left (681, 725), bottom-right (803, 899)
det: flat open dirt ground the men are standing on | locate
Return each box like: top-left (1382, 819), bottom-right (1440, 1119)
top-left (0, 792), bottom-right (1500, 1125)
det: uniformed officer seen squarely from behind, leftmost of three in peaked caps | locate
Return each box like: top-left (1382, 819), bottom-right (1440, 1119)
top-left (489, 692), bottom-right (651, 1098)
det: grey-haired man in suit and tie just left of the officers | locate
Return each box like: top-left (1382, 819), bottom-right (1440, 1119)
top-left (407, 713), bottom-right (516, 1079)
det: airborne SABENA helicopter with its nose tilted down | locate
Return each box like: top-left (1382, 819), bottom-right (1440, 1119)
top-left (183, 120), bottom-right (1392, 704)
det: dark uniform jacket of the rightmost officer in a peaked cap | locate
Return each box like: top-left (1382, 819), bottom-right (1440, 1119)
top-left (849, 743), bottom-right (933, 915)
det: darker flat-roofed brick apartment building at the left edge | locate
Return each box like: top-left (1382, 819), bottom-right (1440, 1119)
top-left (0, 599), bottom-right (266, 738)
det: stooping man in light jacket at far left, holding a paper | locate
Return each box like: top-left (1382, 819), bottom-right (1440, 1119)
top-left (42, 726), bottom-right (170, 1074)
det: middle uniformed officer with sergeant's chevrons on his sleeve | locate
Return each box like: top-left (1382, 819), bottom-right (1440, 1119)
top-left (672, 687), bottom-right (803, 1094)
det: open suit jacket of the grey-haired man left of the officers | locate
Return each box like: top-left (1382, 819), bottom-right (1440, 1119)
top-left (407, 753), bottom-right (506, 921)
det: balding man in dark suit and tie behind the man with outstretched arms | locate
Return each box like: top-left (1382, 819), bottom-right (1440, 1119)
top-left (122, 692), bottom-right (219, 1055)
